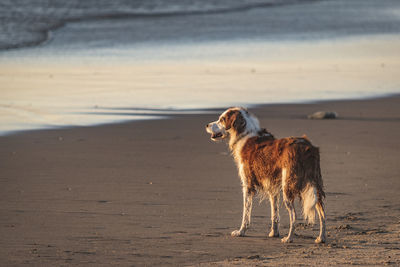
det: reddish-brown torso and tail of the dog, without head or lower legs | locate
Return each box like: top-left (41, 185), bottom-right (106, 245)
top-left (240, 135), bottom-right (325, 223)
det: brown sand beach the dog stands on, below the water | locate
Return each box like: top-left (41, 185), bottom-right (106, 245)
top-left (0, 96), bottom-right (400, 266)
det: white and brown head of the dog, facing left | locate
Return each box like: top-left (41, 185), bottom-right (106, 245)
top-left (206, 107), bottom-right (260, 141)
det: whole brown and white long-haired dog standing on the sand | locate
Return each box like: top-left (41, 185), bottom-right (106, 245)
top-left (206, 107), bottom-right (326, 243)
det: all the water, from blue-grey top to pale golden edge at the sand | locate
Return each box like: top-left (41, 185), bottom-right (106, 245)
top-left (0, 0), bottom-right (400, 134)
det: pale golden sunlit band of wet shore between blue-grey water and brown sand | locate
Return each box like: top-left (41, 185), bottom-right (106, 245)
top-left (0, 33), bottom-right (400, 136)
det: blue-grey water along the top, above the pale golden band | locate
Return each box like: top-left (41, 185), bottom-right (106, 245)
top-left (0, 0), bottom-right (400, 50)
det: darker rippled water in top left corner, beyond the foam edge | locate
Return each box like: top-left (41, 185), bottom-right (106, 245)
top-left (0, 0), bottom-right (312, 49)
